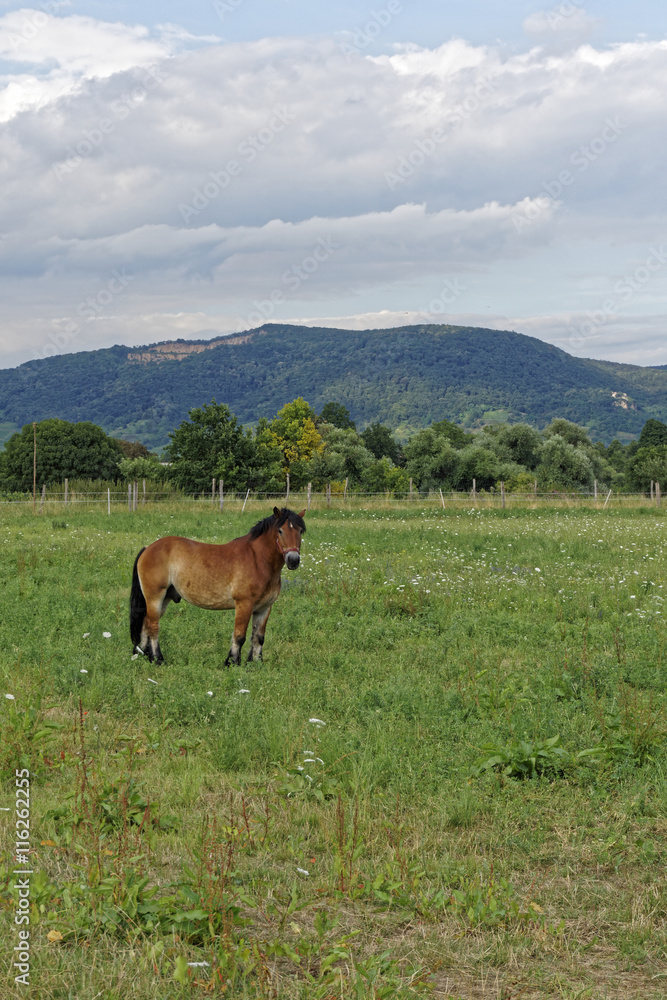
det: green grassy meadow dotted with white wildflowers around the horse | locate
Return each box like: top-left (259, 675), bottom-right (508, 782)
top-left (0, 502), bottom-right (667, 1000)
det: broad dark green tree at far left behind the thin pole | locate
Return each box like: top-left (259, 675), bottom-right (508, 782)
top-left (0, 418), bottom-right (122, 490)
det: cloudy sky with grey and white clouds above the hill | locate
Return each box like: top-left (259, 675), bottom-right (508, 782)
top-left (0, 0), bottom-right (667, 367)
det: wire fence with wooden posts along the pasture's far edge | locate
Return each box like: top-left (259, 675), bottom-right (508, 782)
top-left (0, 483), bottom-right (662, 515)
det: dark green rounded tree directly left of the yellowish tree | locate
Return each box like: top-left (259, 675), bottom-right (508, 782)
top-left (167, 399), bottom-right (254, 493)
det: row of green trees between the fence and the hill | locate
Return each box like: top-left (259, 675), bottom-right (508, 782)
top-left (0, 397), bottom-right (667, 495)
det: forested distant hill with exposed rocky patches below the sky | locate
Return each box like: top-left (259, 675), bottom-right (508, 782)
top-left (0, 323), bottom-right (667, 447)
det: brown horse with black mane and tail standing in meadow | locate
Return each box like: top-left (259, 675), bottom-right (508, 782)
top-left (130, 507), bottom-right (306, 666)
